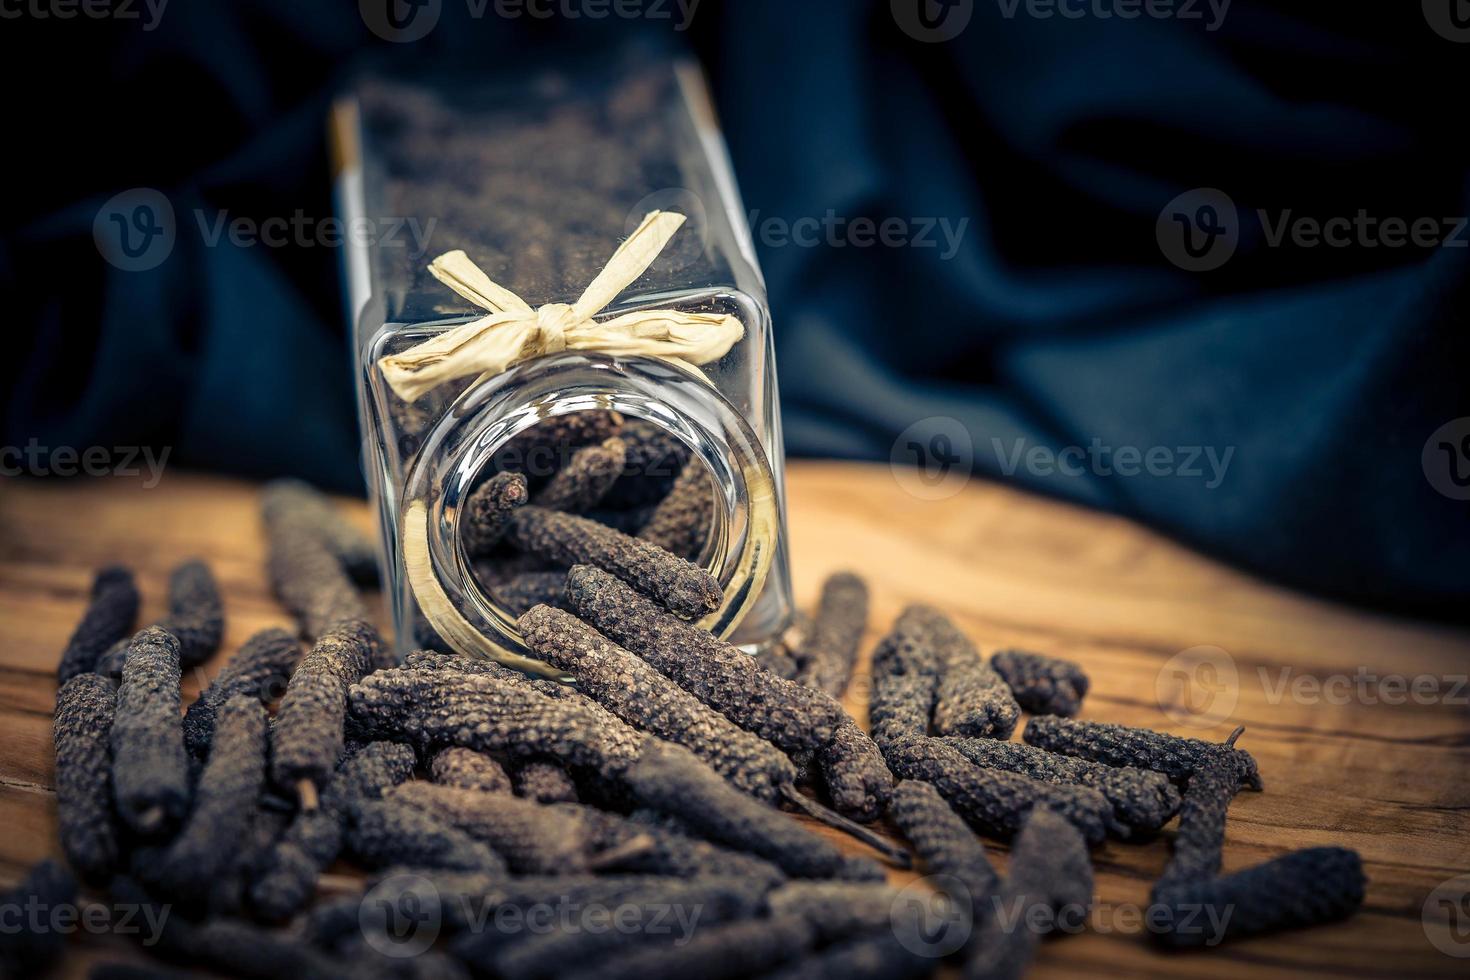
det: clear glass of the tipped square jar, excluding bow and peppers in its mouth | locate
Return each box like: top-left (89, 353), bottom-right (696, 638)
top-left (332, 53), bottom-right (792, 669)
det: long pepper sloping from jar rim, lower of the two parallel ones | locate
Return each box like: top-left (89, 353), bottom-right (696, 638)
top-left (519, 605), bottom-right (793, 802)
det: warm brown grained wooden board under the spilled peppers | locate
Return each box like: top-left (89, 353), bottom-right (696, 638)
top-left (0, 463), bottom-right (1470, 977)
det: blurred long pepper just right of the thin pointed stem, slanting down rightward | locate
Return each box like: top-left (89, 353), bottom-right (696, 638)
top-left (888, 780), bottom-right (1000, 923)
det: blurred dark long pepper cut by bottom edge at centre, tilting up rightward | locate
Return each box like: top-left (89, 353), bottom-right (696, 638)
top-left (563, 918), bottom-right (814, 980)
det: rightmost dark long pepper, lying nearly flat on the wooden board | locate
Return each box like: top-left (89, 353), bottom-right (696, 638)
top-left (1150, 848), bottom-right (1367, 946)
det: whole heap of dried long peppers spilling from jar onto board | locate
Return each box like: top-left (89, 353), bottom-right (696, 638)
top-left (11, 423), bottom-right (1364, 980)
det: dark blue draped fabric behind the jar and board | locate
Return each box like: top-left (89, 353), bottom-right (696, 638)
top-left (0, 0), bottom-right (1470, 617)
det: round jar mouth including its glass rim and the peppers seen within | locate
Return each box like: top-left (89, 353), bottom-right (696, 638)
top-left (400, 353), bottom-right (781, 666)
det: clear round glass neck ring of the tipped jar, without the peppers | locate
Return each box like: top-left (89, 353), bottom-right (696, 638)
top-left (395, 351), bottom-right (781, 669)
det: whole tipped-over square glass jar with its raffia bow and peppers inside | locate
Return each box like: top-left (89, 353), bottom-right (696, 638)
top-left (334, 49), bottom-right (792, 666)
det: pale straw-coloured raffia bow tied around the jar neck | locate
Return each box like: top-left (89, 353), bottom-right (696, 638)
top-left (378, 212), bottom-right (745, 403)
